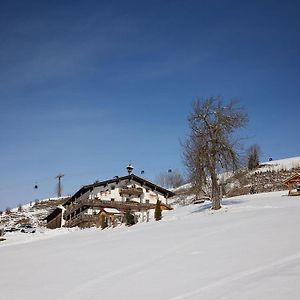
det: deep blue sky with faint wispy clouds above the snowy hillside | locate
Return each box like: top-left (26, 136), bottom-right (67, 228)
top-left (0, 0), bottom-right (300, 209)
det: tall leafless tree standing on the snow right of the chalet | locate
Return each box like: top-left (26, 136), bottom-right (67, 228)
top-left (183, 97), bottom-right (247, 209)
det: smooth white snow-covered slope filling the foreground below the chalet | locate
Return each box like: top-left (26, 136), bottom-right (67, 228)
top-left (0, 192), bottom-right (300, 300)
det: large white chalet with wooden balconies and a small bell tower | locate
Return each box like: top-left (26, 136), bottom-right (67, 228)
top-left (45, 166), bottom-right (175, 229)
